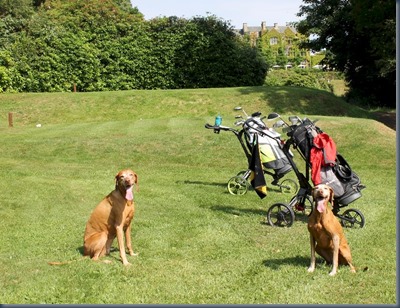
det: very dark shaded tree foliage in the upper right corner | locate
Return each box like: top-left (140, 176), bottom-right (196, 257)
top-left (298, 0), bottom-right (396, 107)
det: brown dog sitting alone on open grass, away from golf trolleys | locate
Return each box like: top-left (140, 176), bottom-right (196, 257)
top-left (83, 169), bottom-right (138, 265)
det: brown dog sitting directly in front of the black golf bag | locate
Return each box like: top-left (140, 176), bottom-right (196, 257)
top-left (308, 184), bottom-right (355, 276)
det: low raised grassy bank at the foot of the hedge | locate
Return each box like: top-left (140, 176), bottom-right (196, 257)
top-left (0, 87), bottom-right (371, 127)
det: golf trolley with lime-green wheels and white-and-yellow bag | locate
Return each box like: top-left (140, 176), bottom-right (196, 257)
top-left (205, 107), bottom-right (298, 195)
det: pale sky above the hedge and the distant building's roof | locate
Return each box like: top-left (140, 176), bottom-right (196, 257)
top-left (131, 0), bottom-right (303, 29)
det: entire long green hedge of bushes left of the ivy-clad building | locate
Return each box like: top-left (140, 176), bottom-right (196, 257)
top-left (0, 0), bottom-right (267, 92)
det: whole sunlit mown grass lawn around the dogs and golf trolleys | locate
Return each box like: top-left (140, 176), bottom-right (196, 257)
top-left (0, 87), bottom-right (396, 304)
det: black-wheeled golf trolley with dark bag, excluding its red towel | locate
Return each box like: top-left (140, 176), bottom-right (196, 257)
top-left (266, 113), bottom-right (365, 228)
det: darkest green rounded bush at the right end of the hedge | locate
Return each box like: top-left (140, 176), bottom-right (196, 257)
top-left (181, 15), bottom-right (267, 87)
